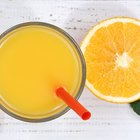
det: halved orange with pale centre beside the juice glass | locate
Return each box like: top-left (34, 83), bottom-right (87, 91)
top-left (81, 17), bottom-right (140, 103)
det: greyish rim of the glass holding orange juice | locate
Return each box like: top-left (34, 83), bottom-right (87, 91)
top-left (0, 22), bottom-right (86, 122)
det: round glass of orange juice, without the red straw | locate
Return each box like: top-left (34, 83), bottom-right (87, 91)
top-left (0, 22), bottom-right (86, 122)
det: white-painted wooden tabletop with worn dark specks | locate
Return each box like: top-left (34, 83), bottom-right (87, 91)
top-left (0, 0), bottom-right (140, 140)
